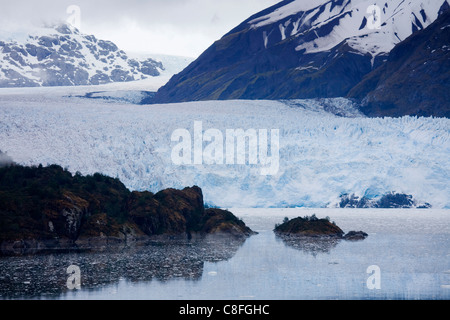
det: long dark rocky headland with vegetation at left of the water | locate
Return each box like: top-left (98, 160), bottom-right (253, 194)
top-left (0, 164), bottom-right (254, 255)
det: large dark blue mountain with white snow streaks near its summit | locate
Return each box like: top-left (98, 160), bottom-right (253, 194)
top-left (155, 0), bottom-right (448, 102)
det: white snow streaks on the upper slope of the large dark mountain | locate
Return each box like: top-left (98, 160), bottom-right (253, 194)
top-left (248, 0), bottom-right (445, 56)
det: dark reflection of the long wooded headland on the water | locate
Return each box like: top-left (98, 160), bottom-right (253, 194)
top-left (0, 237), bottom-right (245, 298)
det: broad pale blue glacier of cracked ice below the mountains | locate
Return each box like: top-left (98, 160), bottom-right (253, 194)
top-left (0, 87), bottom-right (450, 208)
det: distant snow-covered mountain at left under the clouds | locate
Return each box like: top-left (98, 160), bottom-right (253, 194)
top-left (0, 24), bottom-right (164, 87)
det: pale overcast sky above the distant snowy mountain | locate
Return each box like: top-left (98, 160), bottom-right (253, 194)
top-left (0, 0), bottom-right (280, 57)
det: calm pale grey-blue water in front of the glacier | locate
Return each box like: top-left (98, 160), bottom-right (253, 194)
top-left (0, 209), bottom-right (450, 300)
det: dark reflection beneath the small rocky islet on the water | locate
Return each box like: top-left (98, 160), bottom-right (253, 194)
top-left (276, 234), bottom-right (342, 256)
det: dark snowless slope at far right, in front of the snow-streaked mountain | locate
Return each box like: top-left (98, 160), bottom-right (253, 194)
top-left (348, 9), bottom-right (450, 117)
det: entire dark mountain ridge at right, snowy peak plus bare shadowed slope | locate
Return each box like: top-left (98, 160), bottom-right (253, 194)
top-left (150, 0), bottom-right (449, 116)
